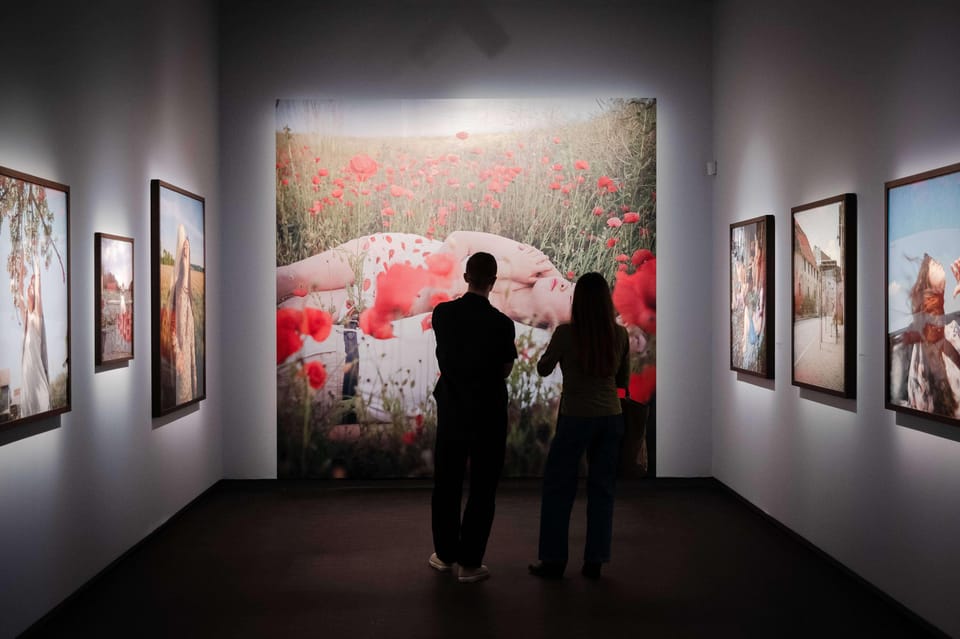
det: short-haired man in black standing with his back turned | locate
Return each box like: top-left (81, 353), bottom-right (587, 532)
top-left (429, 253), bottom-right (517, 583)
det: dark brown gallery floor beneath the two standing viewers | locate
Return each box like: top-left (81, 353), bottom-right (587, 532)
top-left (28, 480), bottom-right (931, 639)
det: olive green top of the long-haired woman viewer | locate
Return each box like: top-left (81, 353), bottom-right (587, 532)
top-left (537, 324), bottom-right (630, 417)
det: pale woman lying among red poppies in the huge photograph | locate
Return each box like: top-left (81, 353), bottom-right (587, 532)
top-left (277, 231), bottom-right (573, 327)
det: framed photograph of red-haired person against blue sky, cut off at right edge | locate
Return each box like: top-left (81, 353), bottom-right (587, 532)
top-left (885, 164), bottom-right (960, 425)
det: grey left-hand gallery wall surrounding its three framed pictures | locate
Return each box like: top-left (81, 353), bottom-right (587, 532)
top-left (0, 0), bottom-right (224, 637)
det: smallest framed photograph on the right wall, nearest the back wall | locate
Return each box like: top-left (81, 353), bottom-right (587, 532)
top-left (730, 215), bottom-right (774, 379)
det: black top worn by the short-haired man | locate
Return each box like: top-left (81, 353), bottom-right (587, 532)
top-left (433, 293), bottom-right (517, 437)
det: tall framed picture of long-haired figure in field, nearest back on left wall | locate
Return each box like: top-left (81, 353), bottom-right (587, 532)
top-left (150, 180), bottom-right (206, 417)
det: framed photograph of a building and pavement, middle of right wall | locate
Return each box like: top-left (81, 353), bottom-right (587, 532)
top-left (791, 193), bottom-right (857, 397)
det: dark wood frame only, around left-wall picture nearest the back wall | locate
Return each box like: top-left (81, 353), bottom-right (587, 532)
top-left (150, 180), bottom-right (207, 417)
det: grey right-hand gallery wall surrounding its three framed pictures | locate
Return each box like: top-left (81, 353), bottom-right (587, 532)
top-left (708, 0), bottom-right (960, 635)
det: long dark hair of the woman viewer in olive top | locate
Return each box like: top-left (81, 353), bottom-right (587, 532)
top-left (571, 273), bottom-right (616, 377)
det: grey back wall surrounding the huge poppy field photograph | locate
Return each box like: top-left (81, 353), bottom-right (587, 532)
top-left (220, 0), bottom-right (712, 478)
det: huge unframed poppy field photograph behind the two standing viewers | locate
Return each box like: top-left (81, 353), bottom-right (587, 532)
top-left (276, 99), bottom-right (657, 478)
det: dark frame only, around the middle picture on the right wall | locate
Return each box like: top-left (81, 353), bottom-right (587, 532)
top-left (790, 193), bottom-right (857, 398)
